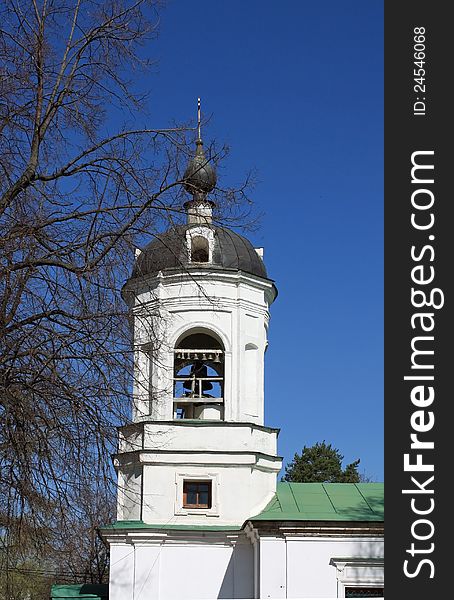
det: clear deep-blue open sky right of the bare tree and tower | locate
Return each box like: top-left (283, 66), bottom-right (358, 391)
top-left (146, 0), bottom-right (383, 481)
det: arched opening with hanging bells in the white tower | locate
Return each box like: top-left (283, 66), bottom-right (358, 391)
top-left (173, 332), bottom-right (224, 421)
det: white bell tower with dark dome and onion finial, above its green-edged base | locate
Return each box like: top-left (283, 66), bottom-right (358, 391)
top-left (115, 109), bottom-right (281, 528)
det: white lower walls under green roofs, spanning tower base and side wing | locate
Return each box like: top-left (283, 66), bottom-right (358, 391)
top-left (110, 530), bottom-right (383, 600)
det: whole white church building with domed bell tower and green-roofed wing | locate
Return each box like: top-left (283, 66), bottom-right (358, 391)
top-left (102, 134), bottom-right (383, 600)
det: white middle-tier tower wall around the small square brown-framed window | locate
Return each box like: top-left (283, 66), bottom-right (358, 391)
top-left (116, 422), bottom-right (281, 526)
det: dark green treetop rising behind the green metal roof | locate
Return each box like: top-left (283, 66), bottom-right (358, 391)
top-left (283, 441), bottom-right (361, 483)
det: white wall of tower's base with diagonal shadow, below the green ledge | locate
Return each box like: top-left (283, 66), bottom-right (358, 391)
top-left (110, 534), bottom-right (254, 600)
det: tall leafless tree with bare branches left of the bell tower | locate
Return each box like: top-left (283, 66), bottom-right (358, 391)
top-left (0, 0), bottom-right (245, 595)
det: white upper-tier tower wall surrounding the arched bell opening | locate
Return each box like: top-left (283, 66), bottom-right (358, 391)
top-left (129, 271), bottom-right (274, 424)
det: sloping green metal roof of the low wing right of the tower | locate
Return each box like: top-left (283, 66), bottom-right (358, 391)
top-left (251, 482), bottom-right (384, 521)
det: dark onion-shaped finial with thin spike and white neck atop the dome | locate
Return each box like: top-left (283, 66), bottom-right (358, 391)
top-left (183, 98), bottom-right (216, 223)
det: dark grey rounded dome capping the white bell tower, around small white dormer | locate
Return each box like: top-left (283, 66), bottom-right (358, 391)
top-left (132, 225), bottom-right (267, 279)
